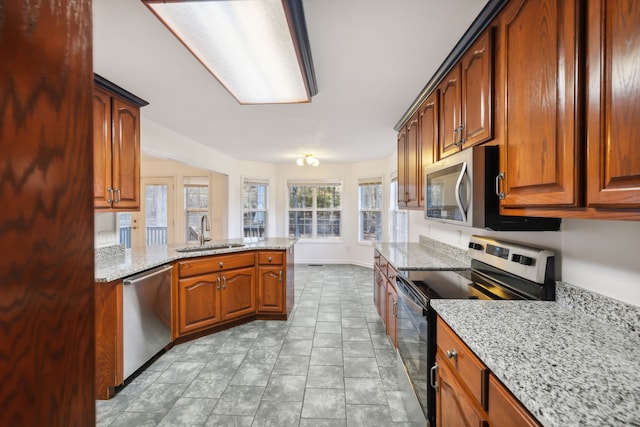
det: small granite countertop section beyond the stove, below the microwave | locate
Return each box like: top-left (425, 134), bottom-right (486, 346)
top-left (374, 236), bottom-right (471, 271)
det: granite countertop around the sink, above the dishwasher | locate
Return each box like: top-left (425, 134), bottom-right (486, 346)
top-left (95, 238), bottom-right (296, 282)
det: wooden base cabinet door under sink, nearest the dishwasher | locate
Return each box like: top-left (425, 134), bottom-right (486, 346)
top-left (178, 273), bottom-right (221, 334)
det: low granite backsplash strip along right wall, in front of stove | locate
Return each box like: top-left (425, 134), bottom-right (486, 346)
top-left (556, 281), bottom-right (640, 336)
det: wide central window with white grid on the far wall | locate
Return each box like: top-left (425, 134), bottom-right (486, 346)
top-left (288, 181), bottom-right (342, 239)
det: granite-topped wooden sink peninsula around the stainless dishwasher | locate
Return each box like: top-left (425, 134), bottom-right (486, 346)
top-left (95, 238), bottom-right (296, 399)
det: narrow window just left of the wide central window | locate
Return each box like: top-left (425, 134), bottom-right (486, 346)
top-left (242, 179), bottom-right (269, 240)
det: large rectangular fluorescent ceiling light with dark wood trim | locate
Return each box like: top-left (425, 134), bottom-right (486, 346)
top-left (142, 0), bottom-right (318, 104)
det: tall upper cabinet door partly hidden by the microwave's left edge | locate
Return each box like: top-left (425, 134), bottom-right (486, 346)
top-left (418, 90), bottom-right (439, 206)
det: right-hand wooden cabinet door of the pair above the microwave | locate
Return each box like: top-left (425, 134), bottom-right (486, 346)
top-left (460, 27), bottom-right (493, 148)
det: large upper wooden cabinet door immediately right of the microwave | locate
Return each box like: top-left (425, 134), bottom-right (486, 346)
top-left (500, 0), bottom-right (582, 207)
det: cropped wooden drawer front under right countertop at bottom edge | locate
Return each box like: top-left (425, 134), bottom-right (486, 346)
top-left (488, 374), bottom-right (540, 427)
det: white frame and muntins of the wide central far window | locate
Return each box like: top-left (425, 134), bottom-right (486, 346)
top-left (285, 179), bottom-right (344, 243)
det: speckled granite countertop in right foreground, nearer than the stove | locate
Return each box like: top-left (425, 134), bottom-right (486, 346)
top-left (431, 300), bottom-right (640, 426)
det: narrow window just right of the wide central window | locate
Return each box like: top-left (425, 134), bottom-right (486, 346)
top-left (358, 178), bottom-right (382, 242)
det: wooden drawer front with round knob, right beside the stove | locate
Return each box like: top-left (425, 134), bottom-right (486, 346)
top-left (436, 318), bottom-right (489, 409)
